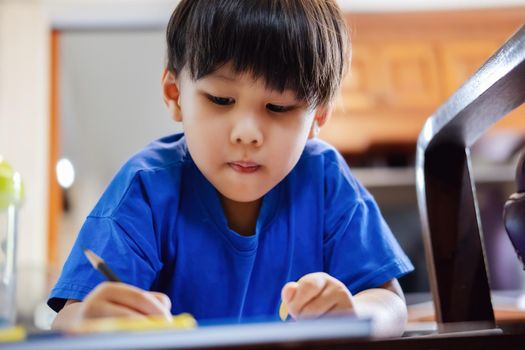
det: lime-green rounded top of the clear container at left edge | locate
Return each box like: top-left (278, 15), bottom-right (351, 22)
top-left (0, 156), bottom-right (24, 211)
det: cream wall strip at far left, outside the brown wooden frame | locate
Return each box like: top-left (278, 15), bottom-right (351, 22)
top-left (0, 1), bottom-right (49, 320)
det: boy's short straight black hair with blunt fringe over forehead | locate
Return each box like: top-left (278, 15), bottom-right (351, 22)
top-left (166, 0), bottom-right (350, 107)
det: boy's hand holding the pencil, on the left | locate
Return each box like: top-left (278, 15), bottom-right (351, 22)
top-left (79, 282), bottom-right (172, 321)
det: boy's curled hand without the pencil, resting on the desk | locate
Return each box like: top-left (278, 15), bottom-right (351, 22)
top-left (281, 272), bottom-right (354, 319)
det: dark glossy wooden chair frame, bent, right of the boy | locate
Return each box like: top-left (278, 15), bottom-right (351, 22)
top-left (416, 19), bottom-right (525, 332)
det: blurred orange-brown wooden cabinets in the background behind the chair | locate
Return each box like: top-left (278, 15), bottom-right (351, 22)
top-left (321, 7), bottom-right (525, 155)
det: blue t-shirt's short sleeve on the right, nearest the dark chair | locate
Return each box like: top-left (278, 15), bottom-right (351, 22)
top-left (324, 156), bottom-right (413, 294)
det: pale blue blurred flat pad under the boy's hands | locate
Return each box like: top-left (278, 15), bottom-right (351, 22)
top-left (3, 317), bottom-right (372, 350)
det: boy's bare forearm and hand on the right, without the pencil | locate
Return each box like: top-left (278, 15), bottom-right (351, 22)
top-left (282, 272), bottom-right (407, 337)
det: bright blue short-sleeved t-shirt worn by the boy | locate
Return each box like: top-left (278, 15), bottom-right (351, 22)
top-left (48, 134), bottom-right (413, 321)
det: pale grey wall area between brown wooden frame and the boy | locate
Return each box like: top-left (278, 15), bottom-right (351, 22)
top-left (57, 29), bottom-right (181, 268)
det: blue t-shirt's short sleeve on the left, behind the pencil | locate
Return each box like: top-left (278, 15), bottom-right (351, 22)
top-left (48, 175), bottom-right (162, 311)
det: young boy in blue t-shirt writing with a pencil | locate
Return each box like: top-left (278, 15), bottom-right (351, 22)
top-left (48, 0), bottom-right (412, 335)
